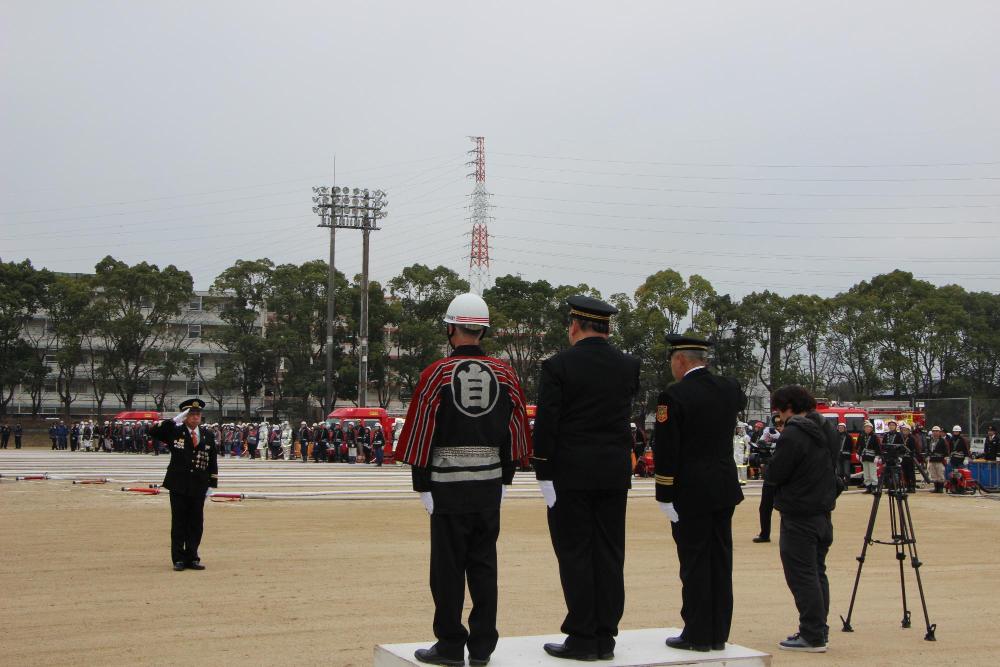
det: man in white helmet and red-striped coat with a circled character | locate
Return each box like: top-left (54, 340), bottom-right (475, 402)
top-left (397, 293), bottom-right (531, 666)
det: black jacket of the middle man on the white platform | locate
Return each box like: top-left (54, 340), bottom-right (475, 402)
top-left (532, 336), bottom-right (640, 491)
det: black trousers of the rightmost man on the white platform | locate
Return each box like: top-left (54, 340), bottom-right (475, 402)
top-left (670, 507), bottom-right (733, 646)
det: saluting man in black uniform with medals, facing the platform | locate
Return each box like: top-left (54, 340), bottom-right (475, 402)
top-left (149, 398), bottom-right (219, 572)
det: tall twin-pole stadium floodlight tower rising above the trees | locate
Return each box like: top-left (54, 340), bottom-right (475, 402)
top-left (313, 186), bottom-right (389, 416)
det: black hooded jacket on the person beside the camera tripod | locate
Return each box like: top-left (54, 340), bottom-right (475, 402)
top-left (765, 412), bottom-right (840, 515)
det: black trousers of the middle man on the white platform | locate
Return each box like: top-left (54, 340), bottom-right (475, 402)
top-left (548, 489), bottom-right (628, 653)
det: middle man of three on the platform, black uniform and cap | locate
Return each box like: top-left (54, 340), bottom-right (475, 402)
top-left (532, 296), bottom-right (640, 660)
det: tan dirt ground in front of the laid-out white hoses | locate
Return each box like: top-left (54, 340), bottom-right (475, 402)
top-left (0, 454), bottom-right (1000, 667)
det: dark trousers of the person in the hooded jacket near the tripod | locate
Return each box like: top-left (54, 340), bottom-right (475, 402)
top-left (779, 513), bottom-right (833, 644)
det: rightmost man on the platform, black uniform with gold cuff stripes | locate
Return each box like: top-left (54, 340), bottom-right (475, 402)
top-left (655, 334), bottom-right (746, 651)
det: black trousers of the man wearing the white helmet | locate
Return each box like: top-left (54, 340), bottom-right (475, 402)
top-left (431, 509), bottom-right (500, 660)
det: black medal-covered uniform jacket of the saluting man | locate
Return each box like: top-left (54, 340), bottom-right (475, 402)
top-left (149, 419), bottom-right (219, 496)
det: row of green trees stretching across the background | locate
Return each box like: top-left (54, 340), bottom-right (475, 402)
top-left (0, 256), bottom-right (1000, 419)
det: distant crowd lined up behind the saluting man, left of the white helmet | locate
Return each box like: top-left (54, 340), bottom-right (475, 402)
top-left (31, 419), bottom-right (390, 466)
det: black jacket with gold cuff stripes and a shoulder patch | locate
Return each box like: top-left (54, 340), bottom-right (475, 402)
top-left (653, 368), bottom-right (746, 520)
